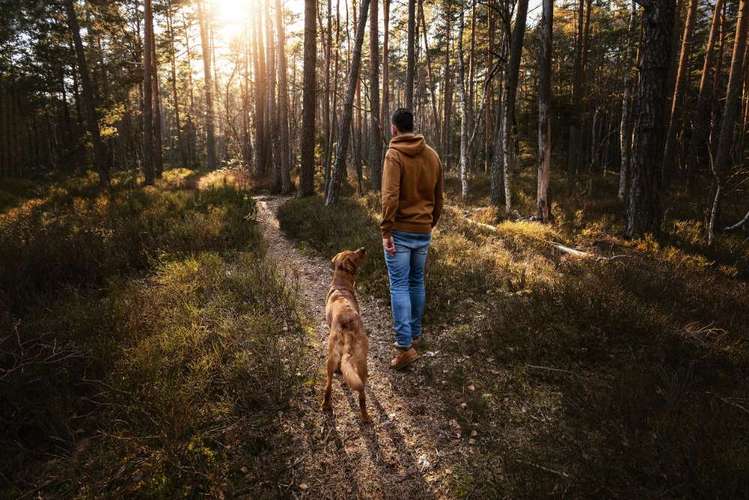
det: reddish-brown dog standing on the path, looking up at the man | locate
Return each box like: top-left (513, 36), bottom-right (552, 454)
top-left (322, 248), bottom-right (370, 422)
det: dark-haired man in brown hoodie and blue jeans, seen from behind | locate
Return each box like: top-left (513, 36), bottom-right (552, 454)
top-left (380, 108), bottom-right (443, 369)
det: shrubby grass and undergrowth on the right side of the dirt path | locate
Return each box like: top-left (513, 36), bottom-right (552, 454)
top-left (280, 174), bottom-right (749, 498)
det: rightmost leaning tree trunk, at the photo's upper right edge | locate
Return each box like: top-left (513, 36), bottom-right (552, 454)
top-left (708, 0), bottom-right (749, 244)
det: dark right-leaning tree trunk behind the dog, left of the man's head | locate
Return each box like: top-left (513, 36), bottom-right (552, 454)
top-left (325, 0), bottom-right (370, 206)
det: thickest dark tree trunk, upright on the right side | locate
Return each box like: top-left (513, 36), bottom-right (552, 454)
top-left (627, 0), bottom-right (675, 237)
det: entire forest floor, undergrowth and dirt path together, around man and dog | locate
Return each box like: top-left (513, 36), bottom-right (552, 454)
top-left (0, 169), bottom-right (749, 499)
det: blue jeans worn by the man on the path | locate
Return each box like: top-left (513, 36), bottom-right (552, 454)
top-left (385, 231), bottom-right (432, 349)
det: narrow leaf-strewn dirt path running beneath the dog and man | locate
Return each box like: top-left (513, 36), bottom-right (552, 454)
top-left (257, 197), bottom-right (468, 500)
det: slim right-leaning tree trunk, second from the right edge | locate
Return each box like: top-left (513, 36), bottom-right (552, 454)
top-left (686, 0), bottom-right (723, 185)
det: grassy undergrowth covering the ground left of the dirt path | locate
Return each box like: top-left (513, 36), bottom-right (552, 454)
top-left (0, 169), bottom-right (313, 497)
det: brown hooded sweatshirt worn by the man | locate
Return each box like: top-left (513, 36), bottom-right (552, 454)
top-left (380, 133), bottom-right (443, 238)
